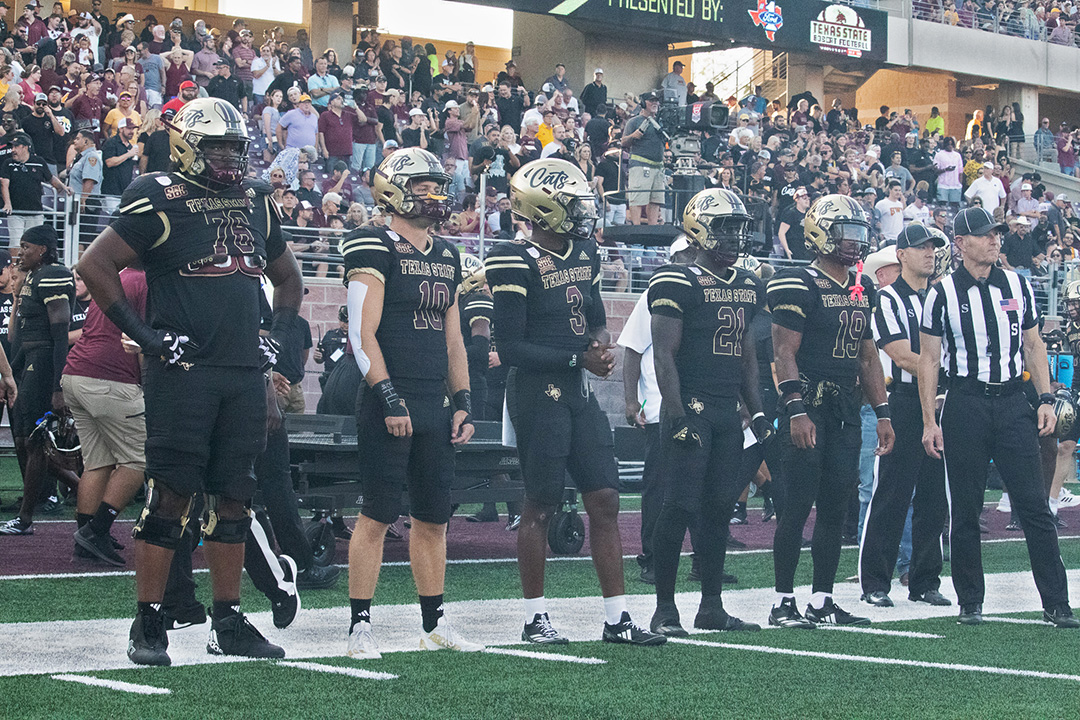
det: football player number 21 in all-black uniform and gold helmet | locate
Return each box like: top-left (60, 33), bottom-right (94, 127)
top-left (648, 189), bottom-right (772, 637)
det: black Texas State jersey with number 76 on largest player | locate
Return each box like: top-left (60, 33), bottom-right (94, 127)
top-left (111, 173), bottom-right (285, 367)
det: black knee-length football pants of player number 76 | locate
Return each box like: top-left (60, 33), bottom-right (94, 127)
top-left (143, 361), bottom-right (267, 502)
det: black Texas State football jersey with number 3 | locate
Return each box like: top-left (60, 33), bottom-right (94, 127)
top-left (484, 240), bottom-right (607, 370)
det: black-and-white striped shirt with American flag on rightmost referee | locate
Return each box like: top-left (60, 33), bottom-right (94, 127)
top-left (920, 266), bottom-right (1039, 382)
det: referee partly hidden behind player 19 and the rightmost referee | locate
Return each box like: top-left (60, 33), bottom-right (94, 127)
top-left (859, 222), bottom-right (953, 608)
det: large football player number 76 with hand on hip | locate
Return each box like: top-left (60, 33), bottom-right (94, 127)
top-left (79, 98), bottom-right (303, 665)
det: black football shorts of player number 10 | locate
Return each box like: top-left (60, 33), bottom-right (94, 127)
top-left (356, 380), bottom-right (454, 525)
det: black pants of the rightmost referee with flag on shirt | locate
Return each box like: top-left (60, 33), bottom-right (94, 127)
top-left (942, 385), bottom-right (1069, 609)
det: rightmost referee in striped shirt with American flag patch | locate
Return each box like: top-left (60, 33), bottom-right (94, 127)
top-left (919, 207), bottom-right (1080, 627)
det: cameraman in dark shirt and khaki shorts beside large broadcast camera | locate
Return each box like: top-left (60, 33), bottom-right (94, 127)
top-left (622, 93), bottom-right (664, 225)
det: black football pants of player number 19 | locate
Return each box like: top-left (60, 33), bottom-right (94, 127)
top-left (772, 398), bottom-right (859, 594)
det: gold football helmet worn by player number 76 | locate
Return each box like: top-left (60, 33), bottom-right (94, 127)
top-left (162, 97), bottom-right (251, 188)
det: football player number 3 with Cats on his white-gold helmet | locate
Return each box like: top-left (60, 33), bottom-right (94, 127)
top-left (485, 159), bottom-right (666, 646)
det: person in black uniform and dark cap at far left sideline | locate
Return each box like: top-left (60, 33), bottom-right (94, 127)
top-left (0, 225), bottom-right (75, 535)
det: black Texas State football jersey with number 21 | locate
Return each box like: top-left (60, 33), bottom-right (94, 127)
top-left (649, 264), bottom-right (765, 397)
